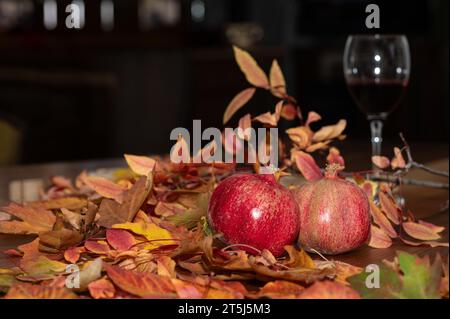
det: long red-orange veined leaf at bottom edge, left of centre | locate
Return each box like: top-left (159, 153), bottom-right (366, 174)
top-left (105, 266), bottom-right (175, 297)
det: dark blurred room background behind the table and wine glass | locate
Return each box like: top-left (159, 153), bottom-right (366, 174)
top-left (0, 0), bottom-right (449, 165)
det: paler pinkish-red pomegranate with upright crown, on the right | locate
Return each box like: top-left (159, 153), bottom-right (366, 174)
top-left (292, 165), bottom-right (370, 255)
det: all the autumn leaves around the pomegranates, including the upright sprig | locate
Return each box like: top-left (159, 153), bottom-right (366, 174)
top-left (0, 48), bottom-right (448, 299)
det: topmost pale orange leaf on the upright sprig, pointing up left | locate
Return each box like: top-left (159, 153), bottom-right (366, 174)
top-left (233, 46), bottom-right (269, 89)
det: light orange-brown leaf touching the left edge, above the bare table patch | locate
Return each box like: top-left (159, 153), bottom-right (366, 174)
top-left (0, 203), bottom-right (56, 235)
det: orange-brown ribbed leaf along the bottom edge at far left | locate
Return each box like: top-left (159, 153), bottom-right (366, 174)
top-left (5, 283), bottom-right (78, 299)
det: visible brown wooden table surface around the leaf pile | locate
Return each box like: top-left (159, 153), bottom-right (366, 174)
top-left (0, 142), bottom-right (449, 267)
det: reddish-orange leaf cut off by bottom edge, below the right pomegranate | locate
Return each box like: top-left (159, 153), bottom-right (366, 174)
top-left (300, 281), bottom-right (361, 299)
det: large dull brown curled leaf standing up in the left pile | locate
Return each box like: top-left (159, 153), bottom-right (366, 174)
top-left (98, 173), bottom-right (153, 228)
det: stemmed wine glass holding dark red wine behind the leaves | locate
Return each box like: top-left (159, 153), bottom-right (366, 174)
top-left (344, 34), bottom-right (411, 171)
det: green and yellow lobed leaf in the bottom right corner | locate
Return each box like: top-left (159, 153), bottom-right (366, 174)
top-left (348, 252), bottom-right (442, 299)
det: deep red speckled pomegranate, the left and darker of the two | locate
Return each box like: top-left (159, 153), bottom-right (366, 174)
top-left (208, 174), bottom-right (299, 256)
